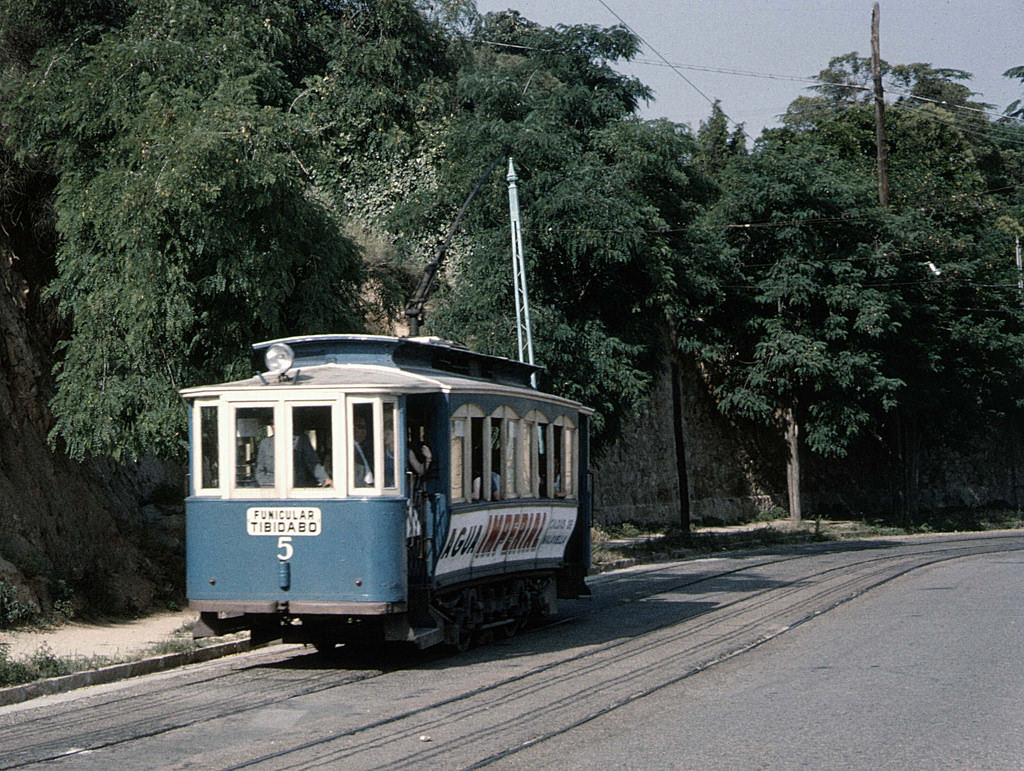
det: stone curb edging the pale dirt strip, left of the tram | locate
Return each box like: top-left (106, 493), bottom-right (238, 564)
top-left (0, 640), bottom-right (251, 706)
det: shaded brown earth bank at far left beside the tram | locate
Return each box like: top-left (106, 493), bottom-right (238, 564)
top-left (0, 249), bottom-right (181, 620)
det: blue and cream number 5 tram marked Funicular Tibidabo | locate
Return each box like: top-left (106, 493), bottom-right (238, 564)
top-left (182, 335), bottom-right (591, 649)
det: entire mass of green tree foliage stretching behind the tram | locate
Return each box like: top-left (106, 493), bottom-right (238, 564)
top-left (0, 0), bottom-right (1024, 481)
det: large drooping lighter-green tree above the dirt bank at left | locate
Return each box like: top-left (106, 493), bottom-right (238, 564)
top-left (4, 0), bottom-right (460, 458)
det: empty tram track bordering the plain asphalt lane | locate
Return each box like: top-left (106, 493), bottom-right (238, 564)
top-left (226, 539), bottom-right (1024, 769)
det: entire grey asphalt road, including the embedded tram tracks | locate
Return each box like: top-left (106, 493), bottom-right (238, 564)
top-left (0, 533), bottom-right (1024, 769)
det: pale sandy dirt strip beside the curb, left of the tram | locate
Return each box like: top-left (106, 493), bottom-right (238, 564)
top-left (0, 610), bottom-right (199, 660)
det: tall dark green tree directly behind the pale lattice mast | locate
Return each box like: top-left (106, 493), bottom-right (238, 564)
top-left (394, 12), bottom-right (716, 454)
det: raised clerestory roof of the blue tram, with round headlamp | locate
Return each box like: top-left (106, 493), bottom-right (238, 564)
top-left (181, 335), bottom-right (589, 412)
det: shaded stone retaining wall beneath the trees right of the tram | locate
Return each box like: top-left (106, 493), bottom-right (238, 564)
top-left (593, 356), bottom-right (1024, 525)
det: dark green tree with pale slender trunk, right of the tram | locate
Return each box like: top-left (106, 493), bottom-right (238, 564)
top-left (690, 129), bottom-right (900, 519)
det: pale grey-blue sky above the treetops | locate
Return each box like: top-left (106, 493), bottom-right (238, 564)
top-left (476, 0), bottom-right (1024, 137)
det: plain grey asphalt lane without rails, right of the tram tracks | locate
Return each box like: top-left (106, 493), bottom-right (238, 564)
top-left (497, 552), bottom-right (1024, 770)
